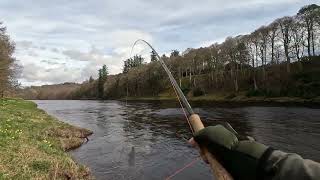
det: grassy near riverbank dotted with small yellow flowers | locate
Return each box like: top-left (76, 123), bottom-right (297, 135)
top-left (0, 99), bottom-right (92, 179)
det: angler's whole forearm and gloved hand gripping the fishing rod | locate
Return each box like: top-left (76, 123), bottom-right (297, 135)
top-left (191, 125), bottom-right (320, 180)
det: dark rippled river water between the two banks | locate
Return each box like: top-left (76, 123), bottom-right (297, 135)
top-left (35, 100), bottom-right (320, 180)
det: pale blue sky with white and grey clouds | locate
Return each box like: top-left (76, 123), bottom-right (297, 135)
top-left (0, 0), bottom-right (320, 86)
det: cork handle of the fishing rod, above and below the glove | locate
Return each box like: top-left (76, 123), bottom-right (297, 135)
top-left (189, 114), bottom-right (233, 180)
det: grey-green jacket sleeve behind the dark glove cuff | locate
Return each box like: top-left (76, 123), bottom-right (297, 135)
top-left (261, 150), bottom-right (320, 180)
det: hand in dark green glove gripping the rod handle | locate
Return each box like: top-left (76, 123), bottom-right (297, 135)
top-left (189, 125), bottom-right (268, 180)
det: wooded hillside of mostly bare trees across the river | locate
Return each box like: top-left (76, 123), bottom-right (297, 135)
top-left (19, 4), bottom-right (320, 102)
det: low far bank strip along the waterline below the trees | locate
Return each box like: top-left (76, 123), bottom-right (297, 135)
top-left (118, 95), bottom-right (320, 106)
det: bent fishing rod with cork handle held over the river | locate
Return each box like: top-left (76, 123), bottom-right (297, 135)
top-left (131, 39), bottom-right (233, 180)
